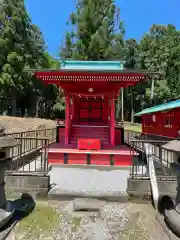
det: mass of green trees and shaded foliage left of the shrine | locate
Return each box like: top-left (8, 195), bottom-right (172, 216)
top-left (0, 0), bottom-right (59, 114)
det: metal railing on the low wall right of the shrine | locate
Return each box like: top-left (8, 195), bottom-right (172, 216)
top-left (124, 130), bottom-right (176, 179)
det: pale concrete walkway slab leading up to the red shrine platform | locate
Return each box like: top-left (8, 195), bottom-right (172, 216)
top-left (49, 165), bottom-right (130, 200)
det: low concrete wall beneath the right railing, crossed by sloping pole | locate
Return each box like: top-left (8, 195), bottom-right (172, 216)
top-left (127, 178), bottom-right (177, 199)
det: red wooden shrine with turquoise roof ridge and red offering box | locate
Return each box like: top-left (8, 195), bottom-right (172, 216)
top-left (35, 61), bottom-right (158, 163)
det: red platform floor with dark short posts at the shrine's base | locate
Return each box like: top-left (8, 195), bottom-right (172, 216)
top-left (48, 143), bottom-right (137, 166)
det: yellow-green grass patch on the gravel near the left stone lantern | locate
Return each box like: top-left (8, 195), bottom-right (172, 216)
top-left (17, 203), bottom-right (61, 239)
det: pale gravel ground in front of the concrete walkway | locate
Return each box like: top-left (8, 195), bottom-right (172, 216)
top-left (8, 201), bottom-right (169, 240)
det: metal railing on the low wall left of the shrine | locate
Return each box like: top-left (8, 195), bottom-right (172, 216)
top-left (4, 128), bottom-right (56, 174)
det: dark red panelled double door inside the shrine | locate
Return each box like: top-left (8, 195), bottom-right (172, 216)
top-left (79, 98), bottom-right (102, 122)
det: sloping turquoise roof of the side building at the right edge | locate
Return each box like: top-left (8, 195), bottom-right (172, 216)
top-left (134, 100), bottom-right (180, 116)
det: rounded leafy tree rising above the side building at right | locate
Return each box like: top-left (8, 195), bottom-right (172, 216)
top-left (138, 25), bottom-right (180, 104)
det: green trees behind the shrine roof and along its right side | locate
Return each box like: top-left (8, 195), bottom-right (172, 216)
top-left (60, 9), bottom-right (180, 119)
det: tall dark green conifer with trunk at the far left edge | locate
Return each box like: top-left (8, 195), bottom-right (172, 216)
top-left (0, 0), bottom-right (44, 115)
